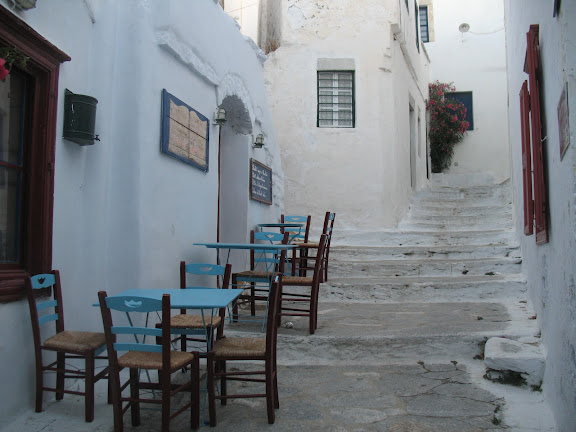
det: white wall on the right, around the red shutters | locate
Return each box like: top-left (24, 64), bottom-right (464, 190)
top-left (505, 0), bottom-right (576, 431)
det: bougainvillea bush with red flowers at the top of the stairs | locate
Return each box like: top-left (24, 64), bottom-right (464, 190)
top-left (426, 81), bottom-right (470, 173)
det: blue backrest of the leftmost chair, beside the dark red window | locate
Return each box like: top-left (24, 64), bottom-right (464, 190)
top-left (25, 270), bottom-right (64, 349)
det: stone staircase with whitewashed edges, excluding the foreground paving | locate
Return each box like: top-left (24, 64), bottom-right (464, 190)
top-left (278, 175), bottom-right (538, 364)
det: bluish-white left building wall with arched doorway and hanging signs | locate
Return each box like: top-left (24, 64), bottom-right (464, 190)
top-left (0, 0), bottom-right (284, 428)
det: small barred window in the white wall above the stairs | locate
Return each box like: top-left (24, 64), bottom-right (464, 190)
top-left (317, 71), bottom-right (355, 128)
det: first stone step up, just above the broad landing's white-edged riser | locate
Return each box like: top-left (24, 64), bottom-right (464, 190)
top-left (329, 258), bottom-right (522, 278)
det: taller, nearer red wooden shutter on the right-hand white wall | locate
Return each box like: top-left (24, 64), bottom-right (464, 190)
top-left (526, 24), bottom-right (548, 244)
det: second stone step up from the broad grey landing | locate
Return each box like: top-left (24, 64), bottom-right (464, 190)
top-left (330, 245), bottom-right (521, 263)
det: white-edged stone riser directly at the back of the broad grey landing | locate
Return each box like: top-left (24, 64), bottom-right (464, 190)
top-left (320, 275), bottom-right (526, 303)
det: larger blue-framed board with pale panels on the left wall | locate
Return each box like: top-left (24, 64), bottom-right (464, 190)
top-left (160, 89), bottom-right (210, 172)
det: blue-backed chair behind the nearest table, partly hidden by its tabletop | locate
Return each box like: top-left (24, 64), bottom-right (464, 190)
top-left (162, 261), bottom-right (232, 351)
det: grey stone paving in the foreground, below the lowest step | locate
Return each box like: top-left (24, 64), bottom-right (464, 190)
top-left (0, 361), bottom-right (552, 432)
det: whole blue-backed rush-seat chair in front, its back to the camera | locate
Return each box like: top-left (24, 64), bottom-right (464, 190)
top-left (98, 291), bottom-right (200, 432)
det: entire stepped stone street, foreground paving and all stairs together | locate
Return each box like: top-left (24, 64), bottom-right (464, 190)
top-left (0, 176), bottom-right (560, 432)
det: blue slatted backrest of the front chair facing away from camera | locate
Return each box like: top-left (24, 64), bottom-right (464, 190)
top-left (98, 291), bottom-right (171, 370)
